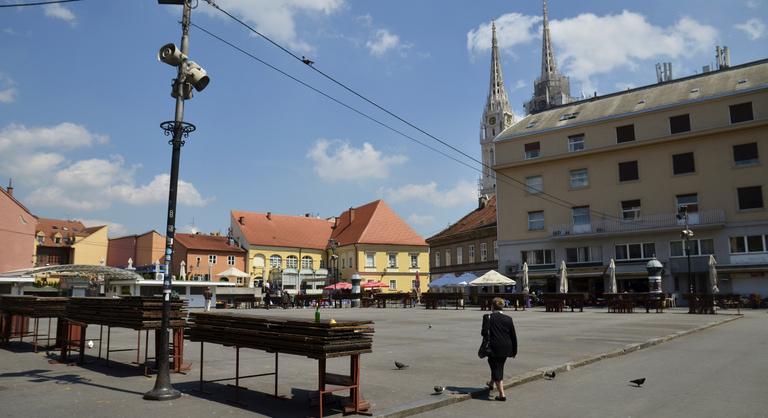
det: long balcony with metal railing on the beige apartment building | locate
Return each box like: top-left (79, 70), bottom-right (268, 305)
top-left (550, 209), bottom-right (725, 239)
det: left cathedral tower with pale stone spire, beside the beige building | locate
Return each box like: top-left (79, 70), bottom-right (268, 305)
top-left (478, 22), bottom-right (515, 196)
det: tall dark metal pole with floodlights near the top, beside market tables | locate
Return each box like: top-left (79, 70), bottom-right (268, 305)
top-left (144, 0), bottom-right (210, 401)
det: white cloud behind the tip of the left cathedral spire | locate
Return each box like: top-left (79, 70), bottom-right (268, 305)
top-left (467, 13), bottom-right (541, 56)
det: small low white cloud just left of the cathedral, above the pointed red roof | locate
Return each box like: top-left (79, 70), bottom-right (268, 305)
top-left (384, 180), bottom-right (477, 207)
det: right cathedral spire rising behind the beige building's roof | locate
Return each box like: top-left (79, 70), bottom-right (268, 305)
top-left (524, 0), bottom-right (573, 114)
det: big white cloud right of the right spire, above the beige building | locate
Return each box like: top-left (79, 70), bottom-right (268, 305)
top-left (550, 10), bottom-right (717, 91)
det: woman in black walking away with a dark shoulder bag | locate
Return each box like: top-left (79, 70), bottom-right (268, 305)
top-left (481, 298), bottom-right (517, 401)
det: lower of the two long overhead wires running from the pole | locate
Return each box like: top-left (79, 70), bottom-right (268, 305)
top-left (191, 23), bottom-right (574, 216)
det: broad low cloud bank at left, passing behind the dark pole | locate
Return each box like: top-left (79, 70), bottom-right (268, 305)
top-left (0, 122), bottom-right (211, 211)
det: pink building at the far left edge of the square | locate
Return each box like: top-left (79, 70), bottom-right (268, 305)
top-left (0, 184), bottom-right (37, 273)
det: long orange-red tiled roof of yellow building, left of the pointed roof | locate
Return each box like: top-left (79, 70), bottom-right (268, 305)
top-left (232, 210), bottom-right (333, 250)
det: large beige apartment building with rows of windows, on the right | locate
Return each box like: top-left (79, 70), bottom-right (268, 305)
top-left (494, 60), bottom-right (768, 297)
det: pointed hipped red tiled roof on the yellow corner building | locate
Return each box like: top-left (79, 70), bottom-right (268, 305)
top-left (333, 200), bottom-right (427, 246)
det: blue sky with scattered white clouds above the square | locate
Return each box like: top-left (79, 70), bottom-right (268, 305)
top-left (0, 0), bottom-right (768, 238)
